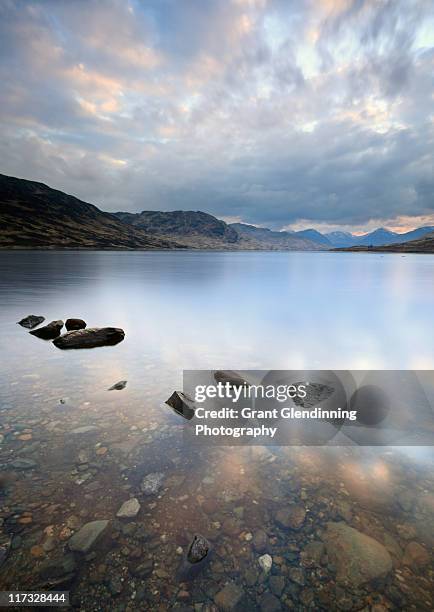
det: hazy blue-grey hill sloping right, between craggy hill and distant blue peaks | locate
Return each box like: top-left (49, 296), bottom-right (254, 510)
top-left (230, 223), bottom-right (324, 251)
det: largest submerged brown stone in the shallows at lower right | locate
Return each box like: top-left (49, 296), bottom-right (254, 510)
top-left (323, 523), bottom-right (392, 587)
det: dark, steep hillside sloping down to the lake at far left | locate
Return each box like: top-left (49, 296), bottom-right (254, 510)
top-left (0, 174), bottom-right (182, 249)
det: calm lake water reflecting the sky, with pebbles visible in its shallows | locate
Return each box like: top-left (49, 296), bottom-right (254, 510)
top-left (0, 252), bottom-right (434, 612)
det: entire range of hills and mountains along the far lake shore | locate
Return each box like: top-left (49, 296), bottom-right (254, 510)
top-left (0, 174), bottom-right (434, 252)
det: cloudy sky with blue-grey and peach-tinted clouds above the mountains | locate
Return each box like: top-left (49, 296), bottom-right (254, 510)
top-left (0, 0), bottom-right (434, 233)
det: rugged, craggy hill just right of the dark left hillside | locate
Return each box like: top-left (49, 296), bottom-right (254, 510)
top-left (114, 210), bottom-right (240, 248)
